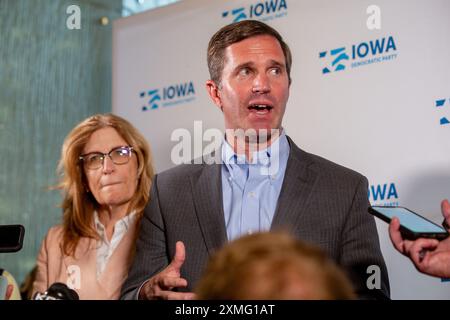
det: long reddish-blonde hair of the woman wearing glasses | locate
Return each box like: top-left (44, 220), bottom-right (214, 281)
top-left (56, 114), bottom-right (154, 256)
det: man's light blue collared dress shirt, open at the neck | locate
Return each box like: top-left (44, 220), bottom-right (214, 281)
top-left (222, 130), bottom-right (290, 241)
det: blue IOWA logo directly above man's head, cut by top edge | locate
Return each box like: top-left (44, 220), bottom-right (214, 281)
top-left (222, 0), bottom-right (287, 22)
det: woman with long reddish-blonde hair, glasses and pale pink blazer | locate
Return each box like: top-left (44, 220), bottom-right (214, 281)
top-left (33, 114), bottom-right (153, 299)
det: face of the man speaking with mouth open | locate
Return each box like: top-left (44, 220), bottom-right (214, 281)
top-left (207, 35), bottom-right (289, 132)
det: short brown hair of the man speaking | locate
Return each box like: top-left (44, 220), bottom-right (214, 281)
top-left (208, 20), bottom-right (292, 85)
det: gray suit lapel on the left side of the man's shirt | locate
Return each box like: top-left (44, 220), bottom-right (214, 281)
top-left (191, 164), bottom-right (227, 254)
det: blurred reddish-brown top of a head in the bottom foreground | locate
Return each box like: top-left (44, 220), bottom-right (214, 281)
top-left (196, 232), bottom-right (355, 300)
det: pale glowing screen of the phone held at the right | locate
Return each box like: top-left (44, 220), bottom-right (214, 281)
top-left (373, 207), bottom-right (446, 233)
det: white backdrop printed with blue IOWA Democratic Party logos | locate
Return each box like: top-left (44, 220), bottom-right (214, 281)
top-left (113, 0), bottom-right (450, 299)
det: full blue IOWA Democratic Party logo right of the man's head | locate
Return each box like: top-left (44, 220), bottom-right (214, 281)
top-left (319, 36), bottom-right (397, 74)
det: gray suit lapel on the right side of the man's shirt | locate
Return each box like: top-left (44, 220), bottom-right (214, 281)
top-left (271, 137), bottom-right (317, 230)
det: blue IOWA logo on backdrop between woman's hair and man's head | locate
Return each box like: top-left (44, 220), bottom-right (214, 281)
top-left (139, 81), bottom-right (195, 111)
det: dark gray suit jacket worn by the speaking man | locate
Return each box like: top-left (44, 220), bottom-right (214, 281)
top-left (122, 139), bottom-right (389, 299)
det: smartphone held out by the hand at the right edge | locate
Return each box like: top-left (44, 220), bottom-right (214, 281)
top-left (369, 206), bottom-right (449, 240)
